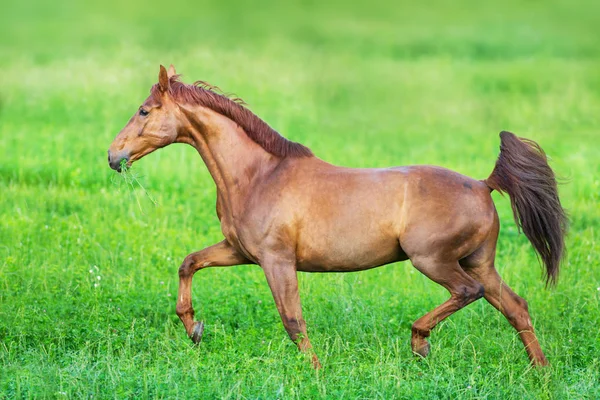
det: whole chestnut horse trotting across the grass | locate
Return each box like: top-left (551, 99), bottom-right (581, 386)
top-left (108, 65), bottom-right (567, 368)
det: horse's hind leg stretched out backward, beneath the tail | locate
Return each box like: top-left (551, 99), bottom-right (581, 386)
top-left (466, 260), bottom-right (548, 366)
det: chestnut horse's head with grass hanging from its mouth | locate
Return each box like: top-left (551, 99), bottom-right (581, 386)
top-left (108, 65), bottom-right (179, 172)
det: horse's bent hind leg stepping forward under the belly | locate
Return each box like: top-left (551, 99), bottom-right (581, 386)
top-left (411, 258), bottom-right (484, 357)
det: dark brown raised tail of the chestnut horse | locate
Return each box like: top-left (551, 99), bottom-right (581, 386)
top-left (485, 131), bottom-right (568, 285)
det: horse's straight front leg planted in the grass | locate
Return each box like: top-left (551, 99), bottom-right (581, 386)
top-left (261, 258), bottom-right (321, 369)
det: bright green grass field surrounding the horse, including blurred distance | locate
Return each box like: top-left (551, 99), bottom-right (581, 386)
top-left (0, 0), bottom-right (600, 399)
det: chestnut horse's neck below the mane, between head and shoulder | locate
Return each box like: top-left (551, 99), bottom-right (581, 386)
top-left (182, 107), bottom-right (279, 217)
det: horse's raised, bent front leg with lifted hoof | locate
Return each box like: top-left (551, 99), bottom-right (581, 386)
top-left (177, 240), bottom-right (252, 343)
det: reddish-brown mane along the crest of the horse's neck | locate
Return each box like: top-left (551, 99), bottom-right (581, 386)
top-left (150, 75), bottom-right (313, 157)
